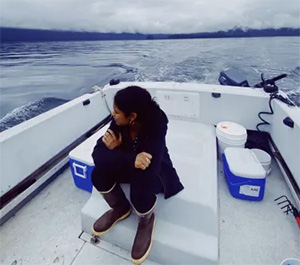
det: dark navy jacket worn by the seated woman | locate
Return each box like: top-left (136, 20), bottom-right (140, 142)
top-left (92, 109), bottom-right (184, 199)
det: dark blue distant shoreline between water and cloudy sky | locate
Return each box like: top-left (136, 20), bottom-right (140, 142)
top-left (0, 27), bottom-right (300, 42)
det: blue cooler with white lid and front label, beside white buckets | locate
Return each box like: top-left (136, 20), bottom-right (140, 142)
top-left (222, 147), bottom-right (266, 201)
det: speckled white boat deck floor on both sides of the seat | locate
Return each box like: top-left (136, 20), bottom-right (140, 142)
top-left (0, 118), bottom-right (300, 265)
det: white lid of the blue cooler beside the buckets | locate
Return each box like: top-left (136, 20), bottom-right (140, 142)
top-left (224, 147), bottom-right (266, 179)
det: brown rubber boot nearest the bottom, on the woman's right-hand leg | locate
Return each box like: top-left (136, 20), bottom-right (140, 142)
top-left (131, 211), bottom-right (155, 264)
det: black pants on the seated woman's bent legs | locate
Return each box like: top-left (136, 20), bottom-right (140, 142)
top-left (92, 162), bottom-right (162, 214)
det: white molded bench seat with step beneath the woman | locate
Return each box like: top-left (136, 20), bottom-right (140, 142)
top-left (81, 120), bottom-right (219, 264)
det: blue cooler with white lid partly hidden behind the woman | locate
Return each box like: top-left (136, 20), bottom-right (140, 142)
top-left (69, 125), bottom-right (109, 192)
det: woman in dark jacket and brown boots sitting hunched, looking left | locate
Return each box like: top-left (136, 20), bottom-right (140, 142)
top-left (92, 86), bottom-right (183, 264)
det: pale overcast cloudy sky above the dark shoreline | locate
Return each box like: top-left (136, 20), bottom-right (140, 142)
top-left (0, 0), bottom-right (300, 34)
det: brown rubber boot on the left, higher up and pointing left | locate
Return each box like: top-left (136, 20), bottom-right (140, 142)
top-left (93, 184), bottom-right (131, 236)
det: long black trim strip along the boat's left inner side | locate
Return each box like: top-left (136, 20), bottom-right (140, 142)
top-left (0, 115), bottom-right (112, 209)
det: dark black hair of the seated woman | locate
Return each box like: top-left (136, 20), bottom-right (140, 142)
top-left (114, 86), bottom-right (161, 125)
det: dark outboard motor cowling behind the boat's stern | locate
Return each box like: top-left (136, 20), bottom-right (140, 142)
top-left (219, 68), bottom-right (249, 87)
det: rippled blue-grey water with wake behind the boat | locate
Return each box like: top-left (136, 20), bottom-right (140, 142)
top-left (0, 37), bottom-right (300, 131)
